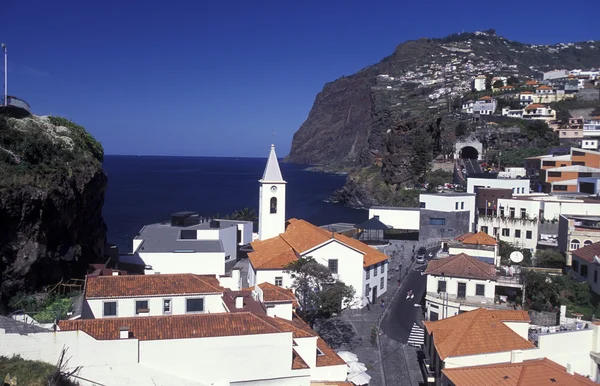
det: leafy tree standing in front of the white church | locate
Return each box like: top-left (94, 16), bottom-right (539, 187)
top-left (286, 256), bottom-right (355, 327)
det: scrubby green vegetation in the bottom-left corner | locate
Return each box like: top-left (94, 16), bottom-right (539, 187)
top-left (0, 356), bottom-right (76, 386)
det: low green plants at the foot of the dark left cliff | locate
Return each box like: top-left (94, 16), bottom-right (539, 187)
top-left (8, 292), bottom-right (76, 323)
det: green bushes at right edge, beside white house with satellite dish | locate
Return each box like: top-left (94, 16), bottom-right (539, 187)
top-left (525, 271), bottom-right (599, 320)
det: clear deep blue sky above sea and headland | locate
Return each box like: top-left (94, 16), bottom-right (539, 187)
top-left (0, 0), bottom-right (600, 157)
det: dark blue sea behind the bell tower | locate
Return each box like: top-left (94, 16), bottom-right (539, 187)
top-left (103, 156), bottom-right (367, 252)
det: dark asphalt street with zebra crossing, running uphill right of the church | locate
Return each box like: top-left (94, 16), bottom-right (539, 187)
top-left (381, 247), bottom-right (439, 343)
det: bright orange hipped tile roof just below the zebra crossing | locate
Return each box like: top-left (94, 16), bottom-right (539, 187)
top-left (424, 308), bottom-right (535, 360)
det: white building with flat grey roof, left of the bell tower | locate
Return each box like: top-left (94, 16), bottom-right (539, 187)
top-left (119, 212), bottom-right (252, 275)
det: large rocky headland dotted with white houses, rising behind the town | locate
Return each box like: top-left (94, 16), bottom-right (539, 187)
top-left (286, 30), bottom-right (600, 204)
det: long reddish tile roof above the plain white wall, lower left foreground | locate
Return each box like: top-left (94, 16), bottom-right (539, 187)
top-left (58, 312), bottom-right (284, 340)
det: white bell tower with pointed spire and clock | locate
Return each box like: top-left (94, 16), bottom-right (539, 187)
top-left (258, 145), bottom-right (286, 240)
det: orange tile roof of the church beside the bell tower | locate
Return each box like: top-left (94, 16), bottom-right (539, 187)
top-left (248, 219), bottom-right (389, 269)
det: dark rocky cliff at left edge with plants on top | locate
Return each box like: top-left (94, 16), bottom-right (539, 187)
top-left (0, 110), bottom-right (107, 303)
